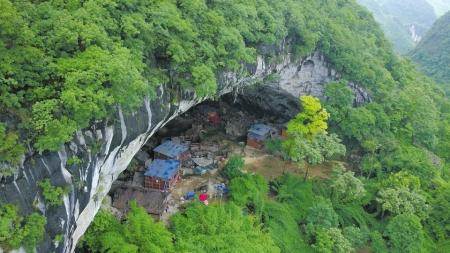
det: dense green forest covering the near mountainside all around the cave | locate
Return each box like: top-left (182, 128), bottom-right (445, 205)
top-left (0, 0), bottom-right (450, 252)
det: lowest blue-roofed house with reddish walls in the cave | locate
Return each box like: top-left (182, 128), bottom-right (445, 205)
top-left (144, 159), bottom-right (180, 191)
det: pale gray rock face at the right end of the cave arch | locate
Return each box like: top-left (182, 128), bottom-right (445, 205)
top-left (235, 52), bottom-right (371, 121)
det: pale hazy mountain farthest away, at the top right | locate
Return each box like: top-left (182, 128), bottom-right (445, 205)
top-left (358, 0), bottom-right (437, 54)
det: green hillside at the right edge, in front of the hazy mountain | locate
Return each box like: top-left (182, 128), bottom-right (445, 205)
top-left (411, 12), bottom-right (450, 91)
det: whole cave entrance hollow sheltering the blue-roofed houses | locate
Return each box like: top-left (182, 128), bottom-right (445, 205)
top-left (108, 95), bottom-right (285, 220)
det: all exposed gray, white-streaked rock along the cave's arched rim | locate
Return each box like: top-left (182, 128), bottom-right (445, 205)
top-left (0, 50), bottom-right (370, 252)
